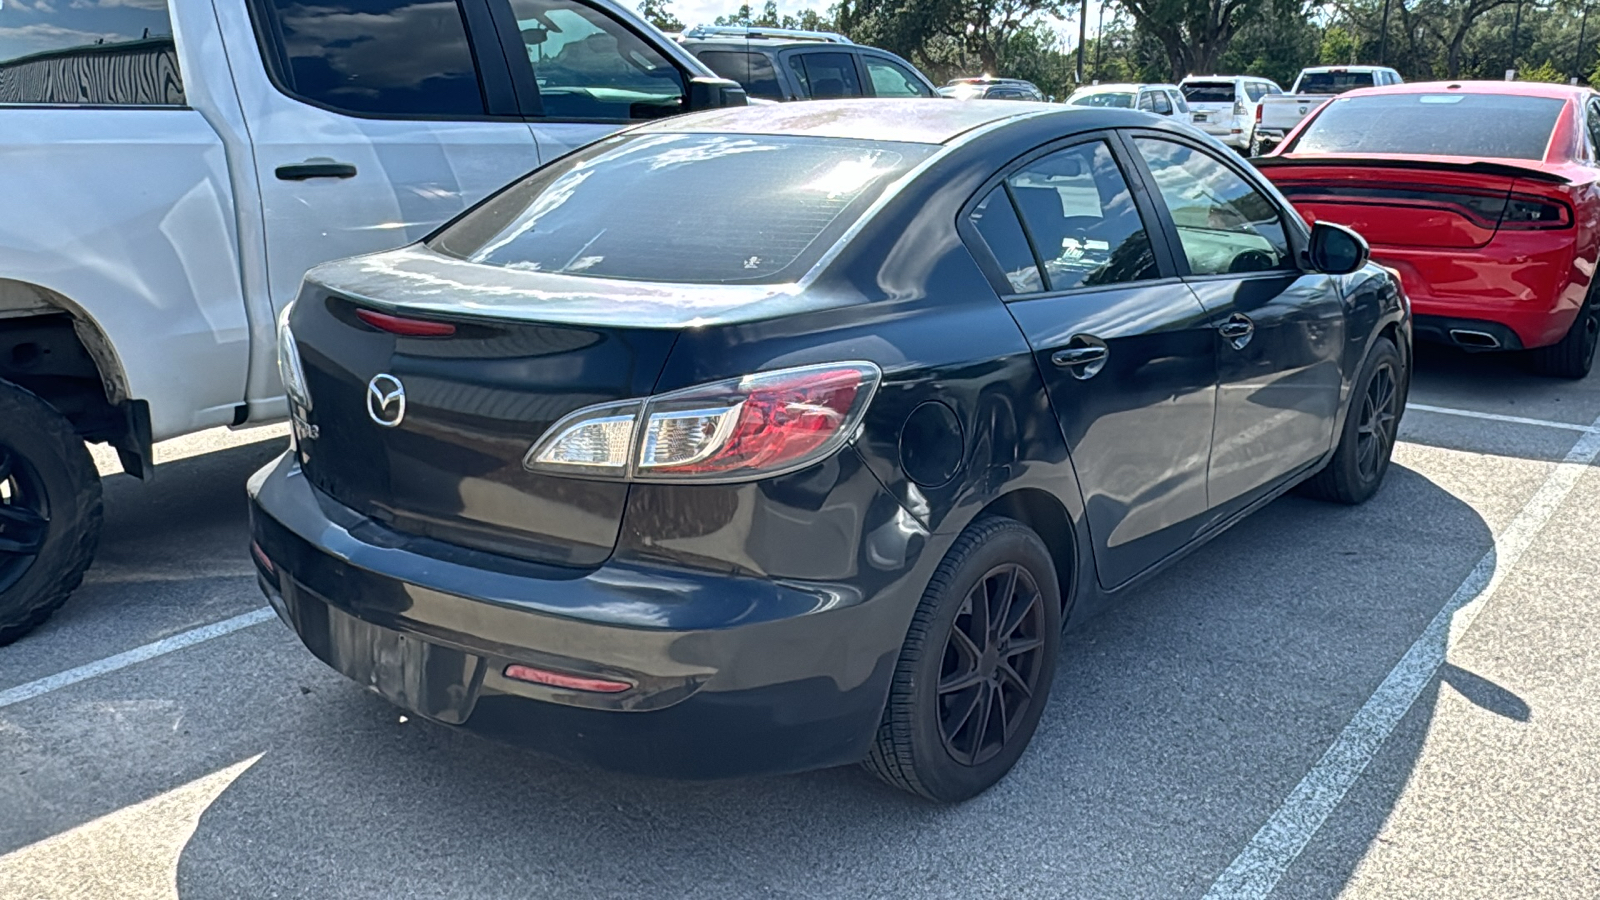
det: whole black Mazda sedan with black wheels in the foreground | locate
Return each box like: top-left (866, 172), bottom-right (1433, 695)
top-left (250, 101), bottom-right (1411, 801)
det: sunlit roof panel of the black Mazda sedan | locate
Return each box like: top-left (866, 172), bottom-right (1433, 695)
top-left (635, 99), bottom-right (1074, 144)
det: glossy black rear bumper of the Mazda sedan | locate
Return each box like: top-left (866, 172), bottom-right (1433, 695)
top-left (250, 456), bottom-right (915, 778)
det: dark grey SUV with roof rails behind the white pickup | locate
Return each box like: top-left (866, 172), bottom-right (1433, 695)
top-left (678, 26), bottom-right (938, 101)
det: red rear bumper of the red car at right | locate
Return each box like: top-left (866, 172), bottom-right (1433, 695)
top-left (1373, 231), bottom-right (1592, 348)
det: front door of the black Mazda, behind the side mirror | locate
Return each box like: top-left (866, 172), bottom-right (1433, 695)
top-left (1128, 135), bottom-right (1346, 517)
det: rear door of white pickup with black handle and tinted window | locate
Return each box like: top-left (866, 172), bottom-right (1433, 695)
top-left (216, 0), bottom-right (539, 318)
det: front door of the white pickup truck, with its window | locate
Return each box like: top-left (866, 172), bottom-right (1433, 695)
top-left (486, 0), bottom-right (688, 159)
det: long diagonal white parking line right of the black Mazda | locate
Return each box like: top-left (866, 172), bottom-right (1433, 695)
top-left (1205, 409), bottom-right (1600, 900)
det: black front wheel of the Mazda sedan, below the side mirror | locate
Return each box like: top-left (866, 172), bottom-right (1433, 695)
top-left (1301, 338), bottom-right (1410, 504)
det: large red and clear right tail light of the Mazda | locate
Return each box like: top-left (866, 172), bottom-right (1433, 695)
top-left (523, 362), bottom-right (883, 482)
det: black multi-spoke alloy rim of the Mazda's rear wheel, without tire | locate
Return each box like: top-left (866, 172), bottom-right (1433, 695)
top-left (938, 562), bottom-right (1045, 765)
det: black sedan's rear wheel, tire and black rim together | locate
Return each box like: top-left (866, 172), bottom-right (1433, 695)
top-left (866, 517), bottom-right (1061, 802)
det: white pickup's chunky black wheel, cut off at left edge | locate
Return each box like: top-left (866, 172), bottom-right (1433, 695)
top-left (0, 381), bottom-right (101, 647)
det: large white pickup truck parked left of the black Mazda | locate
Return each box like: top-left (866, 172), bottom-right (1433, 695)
top-left (0, 0), bottom-right (744, 645)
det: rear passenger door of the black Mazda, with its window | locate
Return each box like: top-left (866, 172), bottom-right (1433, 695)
top-left (963, 136), bottom-right (1216, 586)
